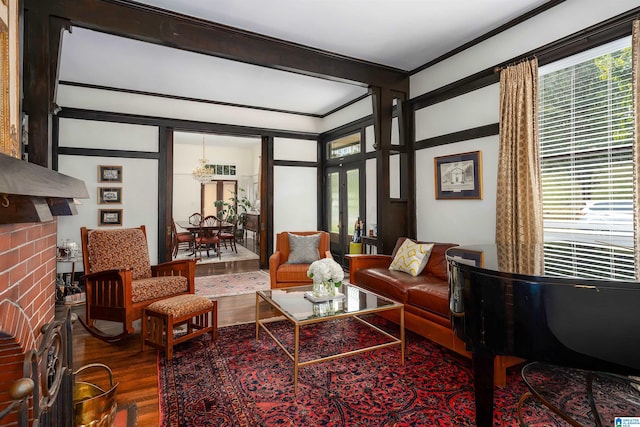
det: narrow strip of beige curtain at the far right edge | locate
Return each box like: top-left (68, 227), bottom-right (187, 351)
top-left (631, 21), bottom-right (640, 280)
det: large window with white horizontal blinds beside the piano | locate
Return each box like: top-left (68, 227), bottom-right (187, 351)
top-left (539, 37), bottom-right (635, 279)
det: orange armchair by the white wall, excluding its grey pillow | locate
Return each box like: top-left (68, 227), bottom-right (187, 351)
top-left (269, 231), bottom-right (333, 289)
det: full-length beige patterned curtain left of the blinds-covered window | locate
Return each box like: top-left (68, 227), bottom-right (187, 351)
top-left (496, 59), bottom-right (544, 274)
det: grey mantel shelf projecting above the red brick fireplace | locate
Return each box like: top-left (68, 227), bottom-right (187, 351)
top-left (0, 153), bottom-right (89, 224)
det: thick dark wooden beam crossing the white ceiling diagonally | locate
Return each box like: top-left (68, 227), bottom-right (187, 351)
top-left (25, 0), bottom-right (409, 93)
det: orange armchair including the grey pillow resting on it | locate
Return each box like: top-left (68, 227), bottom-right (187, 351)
top-left (269, 231), bottom-right (333, 288)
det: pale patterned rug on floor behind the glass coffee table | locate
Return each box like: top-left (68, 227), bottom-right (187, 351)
top-left (195, 270), bottom-right (271, 298)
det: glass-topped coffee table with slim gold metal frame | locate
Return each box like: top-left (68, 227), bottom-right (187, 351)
top-left (256, 284), bottom-right (405, 392)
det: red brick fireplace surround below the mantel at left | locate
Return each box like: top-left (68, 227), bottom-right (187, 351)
top-left (0, 220), bottom-right (57, 426)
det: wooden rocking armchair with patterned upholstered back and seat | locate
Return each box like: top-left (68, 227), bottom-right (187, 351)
top-left (80, 225), bottom-right (196, 342)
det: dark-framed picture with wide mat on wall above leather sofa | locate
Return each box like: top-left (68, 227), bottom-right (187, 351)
top-left (433, 151), bottom-right (482, 199)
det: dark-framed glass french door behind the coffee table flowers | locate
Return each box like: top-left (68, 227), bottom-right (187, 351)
top-left (326, 162), bottom-right (361, 265)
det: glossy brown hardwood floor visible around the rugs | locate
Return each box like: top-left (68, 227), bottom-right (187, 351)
top-left (63, 262), bottom-right (264, 427)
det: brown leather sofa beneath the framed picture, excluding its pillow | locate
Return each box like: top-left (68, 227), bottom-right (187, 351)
top-left (347, 237), bottom-right (522, 386)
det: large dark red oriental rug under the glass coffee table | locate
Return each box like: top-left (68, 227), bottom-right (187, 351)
top-left (158, 318), bottom-right (636, 427)
